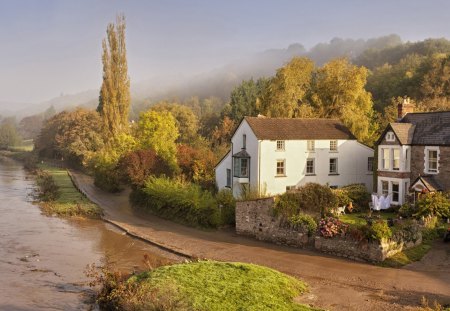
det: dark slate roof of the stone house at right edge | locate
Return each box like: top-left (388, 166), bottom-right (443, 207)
top-left (401, 111), bottom-right (450, 145)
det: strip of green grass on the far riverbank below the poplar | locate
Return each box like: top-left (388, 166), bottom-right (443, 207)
top-left (38, 164), bottom-right (102, 218)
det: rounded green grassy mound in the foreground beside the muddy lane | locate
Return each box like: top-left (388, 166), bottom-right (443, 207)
top-left (98, 261), bottom-right (317, 311)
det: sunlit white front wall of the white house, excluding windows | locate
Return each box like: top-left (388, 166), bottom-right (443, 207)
top-left (260, 140), bottom-right (373, 194)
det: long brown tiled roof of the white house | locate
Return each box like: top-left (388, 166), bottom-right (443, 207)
top-left (245, 117), bottom-right (356, 140)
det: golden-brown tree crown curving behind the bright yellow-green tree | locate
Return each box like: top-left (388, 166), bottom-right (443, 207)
top-left (150, 101), bottom-right (199, 143)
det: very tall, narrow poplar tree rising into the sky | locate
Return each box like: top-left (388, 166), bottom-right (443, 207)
top-left (97, 15), bottom-right (130, 138)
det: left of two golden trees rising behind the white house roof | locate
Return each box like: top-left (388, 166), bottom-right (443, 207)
top-left (263, 57), bottom-right (314, 118)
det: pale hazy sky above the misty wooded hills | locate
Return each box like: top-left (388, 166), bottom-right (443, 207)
top-left (0, 0), bottom-right (450, 108)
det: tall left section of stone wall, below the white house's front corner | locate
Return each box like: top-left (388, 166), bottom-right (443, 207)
top-left (236, 197), bottom-right (314, 247)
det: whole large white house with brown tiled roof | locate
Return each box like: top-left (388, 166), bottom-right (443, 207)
top-left (215, 117), bottom-right (373, 197)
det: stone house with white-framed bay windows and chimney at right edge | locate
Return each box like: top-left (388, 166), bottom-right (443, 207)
top-left (376, 99), bottom-right (450, 205)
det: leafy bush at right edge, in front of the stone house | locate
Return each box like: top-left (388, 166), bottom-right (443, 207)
top-left (415, 192), bottom-right (450, 218)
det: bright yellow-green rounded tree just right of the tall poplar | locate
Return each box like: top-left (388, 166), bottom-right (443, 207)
top-left (136, 110), bottom-right (179, 166)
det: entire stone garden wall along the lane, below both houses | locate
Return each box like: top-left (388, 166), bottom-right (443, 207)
top-left (236, 197), bottom-right (422, 262)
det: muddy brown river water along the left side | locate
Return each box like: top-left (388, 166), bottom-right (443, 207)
top-left (0, 158), bottom-right (178, 311)
